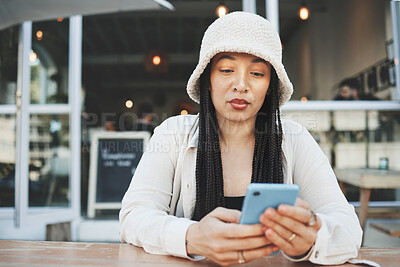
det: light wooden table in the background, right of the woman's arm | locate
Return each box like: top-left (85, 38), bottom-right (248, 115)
top-left (335, 169), bottom-right (400, 229)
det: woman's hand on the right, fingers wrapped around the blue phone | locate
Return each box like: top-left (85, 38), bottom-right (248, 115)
top-left (260, 198), bottom-right (322, 256)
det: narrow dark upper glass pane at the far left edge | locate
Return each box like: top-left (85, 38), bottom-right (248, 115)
top-left (0, 27), bottom-right (19, 105)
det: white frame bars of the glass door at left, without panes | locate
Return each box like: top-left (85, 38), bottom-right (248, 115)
top-left (0, 15), bottom-right (82, 227)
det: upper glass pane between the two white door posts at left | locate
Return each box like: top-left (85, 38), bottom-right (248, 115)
top-left (29, 19), bottom-right (69, 104)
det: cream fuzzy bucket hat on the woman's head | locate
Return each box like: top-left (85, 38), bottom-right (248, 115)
top-left (186, 12), bottom-right (293, 107)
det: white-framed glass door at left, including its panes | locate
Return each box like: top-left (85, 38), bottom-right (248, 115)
top-left (0, 16), bottom-right (82, 227)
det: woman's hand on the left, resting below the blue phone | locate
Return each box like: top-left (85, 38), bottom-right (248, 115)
top-left (186, 208), bottom-right (278, 266)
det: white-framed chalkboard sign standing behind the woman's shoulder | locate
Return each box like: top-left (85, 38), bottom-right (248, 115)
top-left (88, 132), bottom-right (150, 218)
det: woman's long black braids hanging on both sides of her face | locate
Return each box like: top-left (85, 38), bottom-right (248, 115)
top-left (193, 64), bottom-right (283, 221)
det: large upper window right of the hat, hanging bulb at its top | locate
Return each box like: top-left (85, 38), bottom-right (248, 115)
top-left (279, 0), bottom-right (395, 100)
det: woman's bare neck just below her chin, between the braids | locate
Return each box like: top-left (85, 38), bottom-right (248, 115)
top-left (217, 115), bottom-right (255, 149)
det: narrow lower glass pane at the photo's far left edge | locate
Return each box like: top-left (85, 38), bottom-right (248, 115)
top-left (0, 115), bottom-right (15, 207)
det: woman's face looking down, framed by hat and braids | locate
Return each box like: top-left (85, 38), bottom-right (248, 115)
top-left (210, 52), bottom-right (271, 125)
